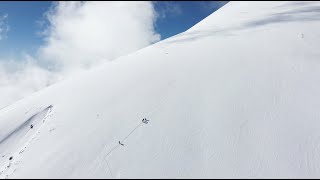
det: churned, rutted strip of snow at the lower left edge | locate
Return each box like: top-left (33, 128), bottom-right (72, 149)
top-left (0, 105), bottom-right (53, 179)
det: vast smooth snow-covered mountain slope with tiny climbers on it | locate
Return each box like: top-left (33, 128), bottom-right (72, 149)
top-left (0, 2), bottom-right (320, 178)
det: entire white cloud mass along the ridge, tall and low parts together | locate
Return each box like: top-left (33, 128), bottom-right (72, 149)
top-left (0, 2), bottom-right (160, 108)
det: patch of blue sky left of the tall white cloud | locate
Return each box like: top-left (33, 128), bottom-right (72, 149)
top-left (0, 1), bottom-right (51, 59)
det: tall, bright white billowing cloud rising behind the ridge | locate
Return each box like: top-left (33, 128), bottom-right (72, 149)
top-left (39, 2), bottom-right (160, 71)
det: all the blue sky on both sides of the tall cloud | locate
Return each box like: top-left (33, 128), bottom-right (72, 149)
top-left (0, 1), bottom-right (225, 59)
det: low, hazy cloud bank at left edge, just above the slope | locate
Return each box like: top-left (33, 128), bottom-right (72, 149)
top-left (0, 55), bottom-right (61, 109)
